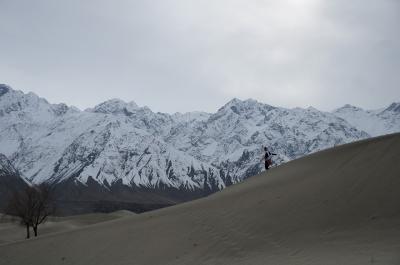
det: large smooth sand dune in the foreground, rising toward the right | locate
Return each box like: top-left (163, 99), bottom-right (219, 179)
top-left (0, 134), bottom-right (400, 265)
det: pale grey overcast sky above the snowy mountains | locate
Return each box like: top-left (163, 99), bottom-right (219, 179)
top-left (0, 0), bottom-right (400, 113)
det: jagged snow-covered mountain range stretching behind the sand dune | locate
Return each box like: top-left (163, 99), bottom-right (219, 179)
top-left (0, 82), bottom-right (400, 200)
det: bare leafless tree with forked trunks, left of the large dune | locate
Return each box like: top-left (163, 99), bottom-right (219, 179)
top-left (5, 184), bottom-right (55, 238)
